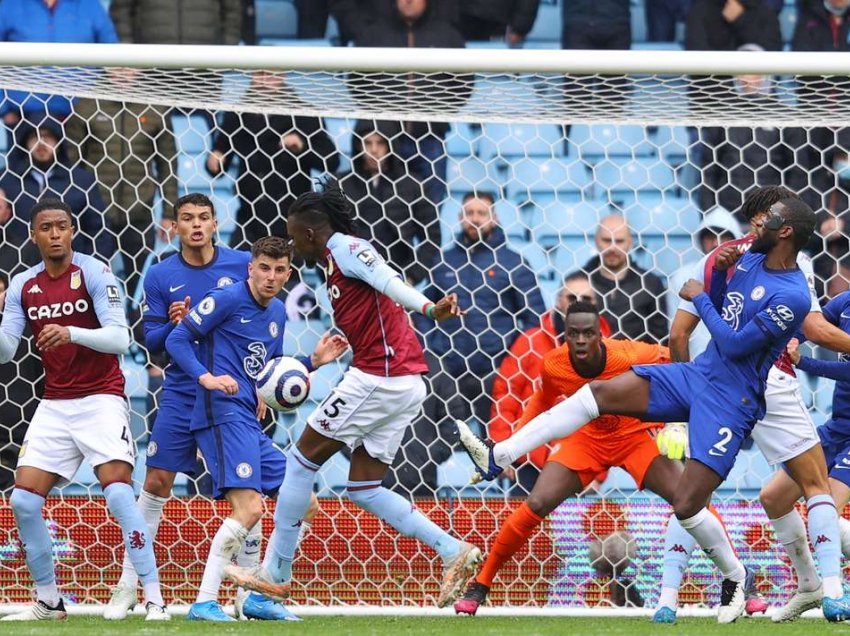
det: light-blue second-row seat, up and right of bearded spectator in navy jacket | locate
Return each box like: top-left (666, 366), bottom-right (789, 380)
top-left (506, 159), bottom-right (593, 203)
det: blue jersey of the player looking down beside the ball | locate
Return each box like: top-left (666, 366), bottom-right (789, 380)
top-left (168, 281), bottom-right (286, 430)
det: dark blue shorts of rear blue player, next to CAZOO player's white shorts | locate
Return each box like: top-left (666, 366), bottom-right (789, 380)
top-left (146, 398), bottom-right (198, 475)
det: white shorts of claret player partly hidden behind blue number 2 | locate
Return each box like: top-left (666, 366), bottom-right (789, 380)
top-left (752, 366), bottom-right (820, 465)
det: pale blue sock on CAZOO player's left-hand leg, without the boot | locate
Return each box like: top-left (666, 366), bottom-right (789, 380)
top-left (9, 488), bottom-right (59, 607)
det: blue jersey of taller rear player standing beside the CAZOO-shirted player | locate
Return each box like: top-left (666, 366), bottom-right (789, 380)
top-left (142, 246), bottom-right (251, 398)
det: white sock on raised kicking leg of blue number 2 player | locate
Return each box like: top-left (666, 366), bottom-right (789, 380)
top-left (493, 384), bottom-right (599, 466)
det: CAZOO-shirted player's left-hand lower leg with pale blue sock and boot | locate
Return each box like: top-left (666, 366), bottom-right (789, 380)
top-left (0, 488), bottom-right (68, 621)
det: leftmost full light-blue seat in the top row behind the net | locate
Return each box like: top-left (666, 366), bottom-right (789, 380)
top-left (478, 124), bottom-right (564, 159)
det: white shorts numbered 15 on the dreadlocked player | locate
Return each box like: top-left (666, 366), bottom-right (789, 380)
top-left (307, 367), bottom-right (426, 465)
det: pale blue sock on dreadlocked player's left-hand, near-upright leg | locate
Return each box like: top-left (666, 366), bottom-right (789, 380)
top-left (263, 446), bottom-right (320, 581)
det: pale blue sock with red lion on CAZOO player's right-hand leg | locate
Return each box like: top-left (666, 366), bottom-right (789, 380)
top-left (103, 481), bottom-right (163, 605)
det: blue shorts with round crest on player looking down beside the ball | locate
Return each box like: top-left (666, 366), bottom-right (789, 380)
top-left (195, 421), bottom-right (286, 499)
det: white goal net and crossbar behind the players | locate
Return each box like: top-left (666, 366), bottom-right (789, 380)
top-left (0, 44), bottom-right (850, 608)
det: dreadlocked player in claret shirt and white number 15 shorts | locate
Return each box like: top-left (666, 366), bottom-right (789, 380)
top-left (227, 179), bottom-right (481, 607)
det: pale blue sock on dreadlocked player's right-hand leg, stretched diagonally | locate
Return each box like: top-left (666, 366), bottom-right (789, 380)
top-left (347, 481), bottom-right (460, 560)
